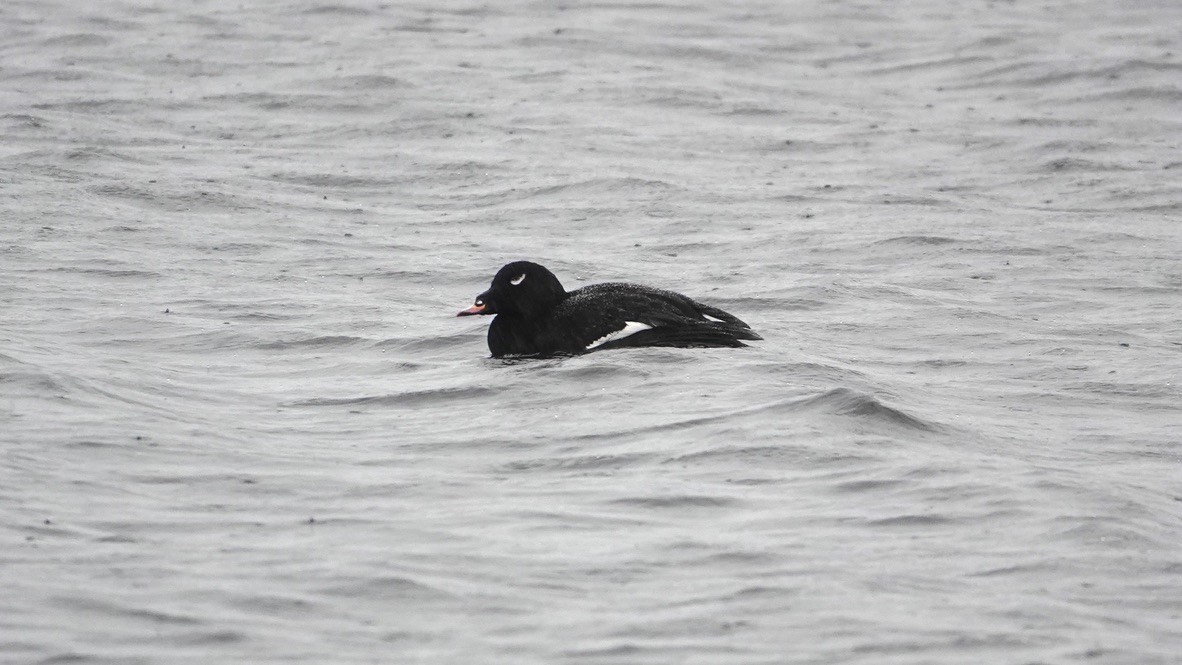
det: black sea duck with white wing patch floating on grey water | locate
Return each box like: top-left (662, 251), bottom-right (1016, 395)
top-left (457, 261), bottom-right (762, 358)
